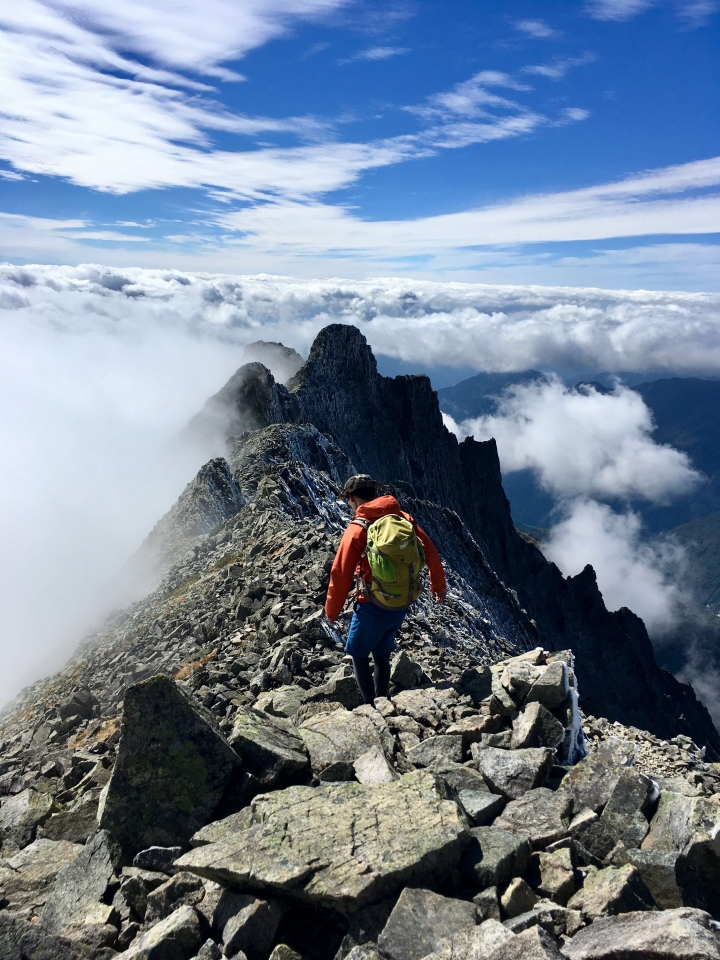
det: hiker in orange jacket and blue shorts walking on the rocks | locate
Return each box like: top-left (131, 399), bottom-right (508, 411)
top-left (325, 473), bottom-right (447, 704)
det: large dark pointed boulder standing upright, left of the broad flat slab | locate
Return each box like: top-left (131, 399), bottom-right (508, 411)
top-left (100, 676), bottom-right (240, 858)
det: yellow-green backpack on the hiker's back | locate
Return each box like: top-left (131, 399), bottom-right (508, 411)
top-left (352, 513), bottom-right (425, 610)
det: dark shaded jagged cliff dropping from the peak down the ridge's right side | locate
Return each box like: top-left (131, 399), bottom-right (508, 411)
top-left (208, 324), bottom-right (720, 756)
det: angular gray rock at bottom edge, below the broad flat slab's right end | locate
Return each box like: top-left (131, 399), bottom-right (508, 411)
top-left (378, 887), bottom-right (475, 960)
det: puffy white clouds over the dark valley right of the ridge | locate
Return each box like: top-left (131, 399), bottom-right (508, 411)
top-left (445, 378), bottom-right (702, 637)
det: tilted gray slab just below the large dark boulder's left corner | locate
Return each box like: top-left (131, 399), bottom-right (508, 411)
top-left (40, 830), bottom-right (121, 934)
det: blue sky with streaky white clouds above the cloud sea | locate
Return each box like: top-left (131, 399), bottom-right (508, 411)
top-left (0, 0), bottom-right (720, 291)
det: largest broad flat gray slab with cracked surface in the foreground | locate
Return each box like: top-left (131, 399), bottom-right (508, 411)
top-left (177, 772), bottom-right (467, 914)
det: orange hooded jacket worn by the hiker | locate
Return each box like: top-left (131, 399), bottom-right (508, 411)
top-left (325, 497), bottom-right (447, 620)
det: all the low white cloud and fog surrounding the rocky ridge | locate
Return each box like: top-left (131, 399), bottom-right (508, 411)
top-left (0, 265), bottom-right (720, 702)
